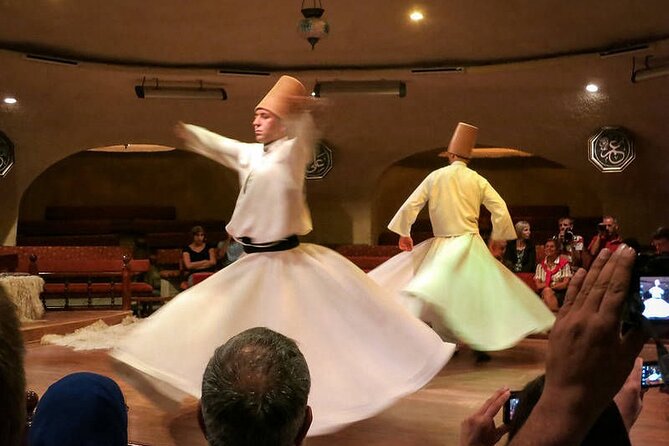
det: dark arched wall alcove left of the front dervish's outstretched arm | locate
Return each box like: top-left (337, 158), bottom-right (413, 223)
top-left (19, 150), bottom-right (238, 220)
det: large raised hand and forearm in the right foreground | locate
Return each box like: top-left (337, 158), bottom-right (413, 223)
top-left (509, 245), bottom-right (646, 446)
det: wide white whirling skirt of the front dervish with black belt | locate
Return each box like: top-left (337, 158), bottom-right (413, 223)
top-left (111, 244), bottom-right (454, 436)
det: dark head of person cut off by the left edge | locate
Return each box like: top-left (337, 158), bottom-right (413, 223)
top-left (0, 287), bottom-right (26, 446)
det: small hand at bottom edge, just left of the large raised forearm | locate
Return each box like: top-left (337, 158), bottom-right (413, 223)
top-left (460, 387), bottom-right (511, 446)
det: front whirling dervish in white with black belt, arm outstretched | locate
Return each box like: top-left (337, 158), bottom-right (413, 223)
top-left (111, 76), bottom-right (454, 435)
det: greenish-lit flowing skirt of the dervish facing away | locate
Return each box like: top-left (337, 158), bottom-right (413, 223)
top-left (369, 234), bottom-right (555, 351)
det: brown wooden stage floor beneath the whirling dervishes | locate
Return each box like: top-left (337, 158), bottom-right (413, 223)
top-left (26, 314), bottom-right (669, 446)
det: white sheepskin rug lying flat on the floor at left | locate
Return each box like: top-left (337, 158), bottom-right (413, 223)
top-left (40, 316), bottom-right (140, 351)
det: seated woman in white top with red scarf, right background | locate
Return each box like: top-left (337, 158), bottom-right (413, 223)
top-left (534, 239), bottom-right (572, 311)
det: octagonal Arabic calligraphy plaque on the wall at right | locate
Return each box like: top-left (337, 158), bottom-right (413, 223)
top-left (588, 127), bottom-right (636, 173)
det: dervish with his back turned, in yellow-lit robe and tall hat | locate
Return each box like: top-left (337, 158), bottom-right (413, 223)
top-left (369, 123), bottom-right (555, 351)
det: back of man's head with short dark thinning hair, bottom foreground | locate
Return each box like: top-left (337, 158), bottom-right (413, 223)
top-left (201, 327), bottom-right (311, 446)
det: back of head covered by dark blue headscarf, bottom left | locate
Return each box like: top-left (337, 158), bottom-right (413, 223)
top-left (30, 372), bottom-right (128, 446)
